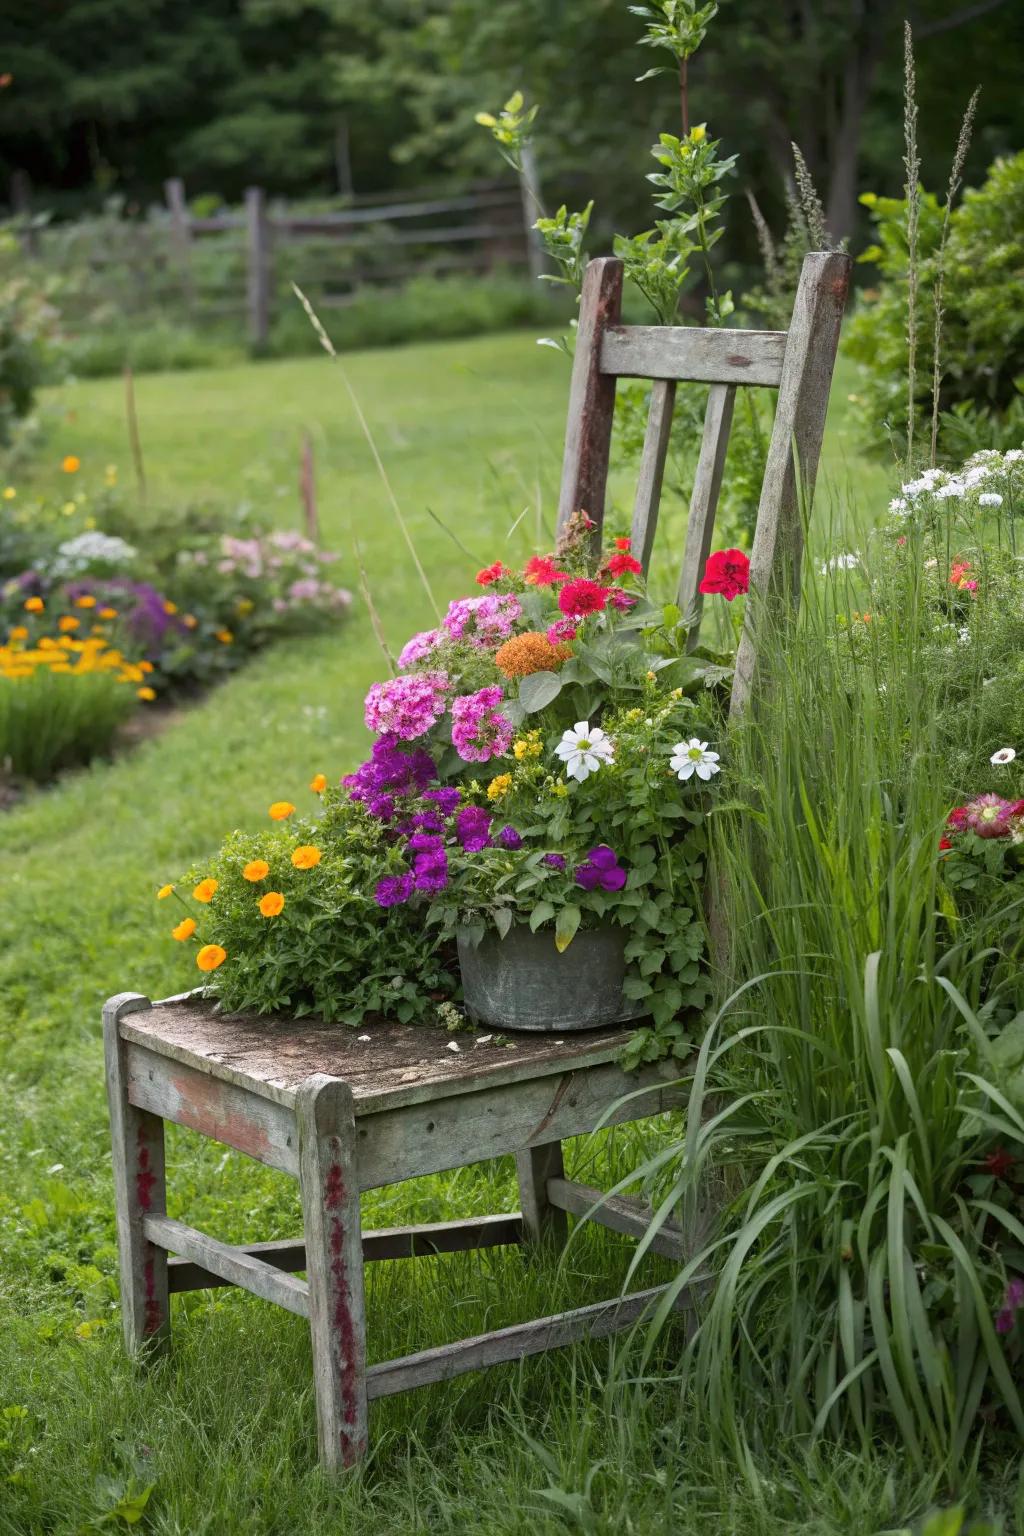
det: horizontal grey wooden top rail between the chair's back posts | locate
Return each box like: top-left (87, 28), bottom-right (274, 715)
top-left (599, 326), bottom-right (789, 389)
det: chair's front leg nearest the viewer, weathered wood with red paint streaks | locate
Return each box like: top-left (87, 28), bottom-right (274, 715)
top-left (296, 1074), bottom-right (367, 1471)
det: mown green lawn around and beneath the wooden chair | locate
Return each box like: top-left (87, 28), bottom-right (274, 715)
top-left (0, 335), bottom-right (929, 1536)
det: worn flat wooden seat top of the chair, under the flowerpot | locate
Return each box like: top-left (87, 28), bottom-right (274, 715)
top-left (120, 992), bottom-right (641, 1117)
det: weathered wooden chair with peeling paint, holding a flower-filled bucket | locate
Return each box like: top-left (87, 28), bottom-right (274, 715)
top-left (103, 245), bottom-right (849, 1468)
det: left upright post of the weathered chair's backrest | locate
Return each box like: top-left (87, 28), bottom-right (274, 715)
top-left (559, 257), bottom-right (622, 553)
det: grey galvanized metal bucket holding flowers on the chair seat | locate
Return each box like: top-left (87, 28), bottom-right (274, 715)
top-left (457, 926), bottom-right (637, 1034)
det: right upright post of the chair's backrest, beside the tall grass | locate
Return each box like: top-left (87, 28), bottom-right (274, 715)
top-left (731, 250), bottom-right (852, 719)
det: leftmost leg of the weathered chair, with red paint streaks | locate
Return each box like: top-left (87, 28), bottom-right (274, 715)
top-left (103, 992), bottom-right (170, 1355)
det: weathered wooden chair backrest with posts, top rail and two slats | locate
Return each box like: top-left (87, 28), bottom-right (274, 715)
top-left (559, 252), bottom-right (851, 714)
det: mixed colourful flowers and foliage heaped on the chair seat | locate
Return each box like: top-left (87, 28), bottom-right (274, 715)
top-left (160, 528), bottom-right (745, 1061)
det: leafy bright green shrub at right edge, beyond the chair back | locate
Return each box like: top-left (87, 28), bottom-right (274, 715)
top-left (846, 152), bottom-right (1024, 456)
